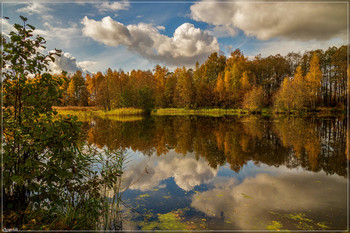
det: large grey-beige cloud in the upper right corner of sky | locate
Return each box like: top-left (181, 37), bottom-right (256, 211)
top-left (191, 1), bottom-right (347, 41)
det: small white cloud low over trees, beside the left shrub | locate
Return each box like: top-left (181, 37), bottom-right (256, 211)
top-left (49, 52), bottom-right (93, 74)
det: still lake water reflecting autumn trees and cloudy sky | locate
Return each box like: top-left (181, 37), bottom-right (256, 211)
top-left (85, 116), bottom-right (348, 230)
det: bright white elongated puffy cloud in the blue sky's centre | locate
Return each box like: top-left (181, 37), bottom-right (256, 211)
top-left (82, 16), bottom-right (219, 65)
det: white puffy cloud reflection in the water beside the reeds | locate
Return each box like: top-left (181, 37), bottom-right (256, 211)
top-left (123, 151), bottom-right (217, 191)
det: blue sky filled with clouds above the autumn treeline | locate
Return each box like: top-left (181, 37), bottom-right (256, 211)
top-left (2, 0), bottom-right (348, 73)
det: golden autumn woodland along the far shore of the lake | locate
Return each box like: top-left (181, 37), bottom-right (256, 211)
top-left (20, 45), bottom-right (349, 112)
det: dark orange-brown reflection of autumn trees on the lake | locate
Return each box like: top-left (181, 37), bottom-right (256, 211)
top-left (86, 116), bottom-right (347, 176)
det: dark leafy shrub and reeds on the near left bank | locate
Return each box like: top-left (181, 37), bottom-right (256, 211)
top-left (1, 17), bottom-right (126, 231)
